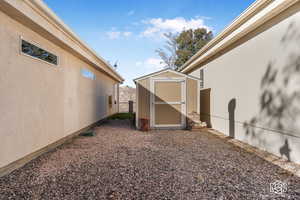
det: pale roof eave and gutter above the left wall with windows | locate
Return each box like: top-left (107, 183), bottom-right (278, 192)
top-left (0, 0), bottom-right (124, 82)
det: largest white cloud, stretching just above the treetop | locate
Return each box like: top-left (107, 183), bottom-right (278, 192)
top-left (141, 17), bottom-right (210, 37)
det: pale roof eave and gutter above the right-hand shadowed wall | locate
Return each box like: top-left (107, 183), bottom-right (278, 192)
top-left (179, 0), bottom-right (299, 73)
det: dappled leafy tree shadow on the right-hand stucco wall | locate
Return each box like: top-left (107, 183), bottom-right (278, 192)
top-left (244, 22), bottom-right (300, 160)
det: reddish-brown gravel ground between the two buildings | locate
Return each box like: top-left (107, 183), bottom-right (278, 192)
top-left (0, 120), bottom-right (300, 200)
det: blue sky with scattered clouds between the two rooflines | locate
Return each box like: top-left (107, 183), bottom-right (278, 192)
top-left (44, 0), bottom-right (254, 86)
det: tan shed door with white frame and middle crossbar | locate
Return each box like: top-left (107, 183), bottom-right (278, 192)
top-left (151, 79), bottom-right (186, 128)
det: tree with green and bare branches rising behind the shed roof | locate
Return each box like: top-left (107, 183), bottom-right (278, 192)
top-left (156, 28), bottom-right (213, 70)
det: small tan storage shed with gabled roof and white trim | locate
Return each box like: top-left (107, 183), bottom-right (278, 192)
top-left (134, 69), bottom-right (200, 129)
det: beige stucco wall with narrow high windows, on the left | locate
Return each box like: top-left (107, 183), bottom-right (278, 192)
top-left (0, 11), bottom-right (117, 167)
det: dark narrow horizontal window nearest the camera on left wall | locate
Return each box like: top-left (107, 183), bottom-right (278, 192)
top-left (21, 40), bottom-right (58, 65)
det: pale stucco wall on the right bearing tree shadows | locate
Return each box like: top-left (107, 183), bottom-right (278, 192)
top-left (191, 3), bottom-right (300, 163)
